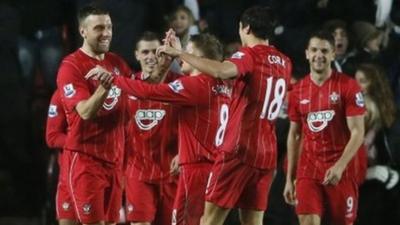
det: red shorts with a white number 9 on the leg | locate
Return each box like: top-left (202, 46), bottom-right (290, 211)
top-left (296, 178), bottom-right (358, 225)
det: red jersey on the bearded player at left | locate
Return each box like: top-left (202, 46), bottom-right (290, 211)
top-left (57, 50), bottom-right (131, 163)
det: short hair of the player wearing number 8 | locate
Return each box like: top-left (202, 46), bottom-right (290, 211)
top-left (190, 33), bottom-right (224, 61)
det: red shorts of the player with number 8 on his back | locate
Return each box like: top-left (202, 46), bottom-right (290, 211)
top-left (172, 163), bottom-right (212, 225)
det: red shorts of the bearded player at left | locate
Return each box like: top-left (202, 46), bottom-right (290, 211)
top-left (68, 152), bottom-right (122, 224)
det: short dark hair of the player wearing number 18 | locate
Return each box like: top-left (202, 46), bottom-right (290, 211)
top-left (240, 6), bottom-right (276, 39)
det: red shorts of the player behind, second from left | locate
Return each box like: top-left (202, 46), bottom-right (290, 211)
top-left (125, 170), bottom-right (177, 225)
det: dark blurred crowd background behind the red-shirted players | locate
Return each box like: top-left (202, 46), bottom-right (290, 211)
top-left (0, 0), bottom-right (400, 224)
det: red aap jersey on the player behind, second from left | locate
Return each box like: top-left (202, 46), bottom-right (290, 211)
top-left (127, 72), bottom-right (178, 181)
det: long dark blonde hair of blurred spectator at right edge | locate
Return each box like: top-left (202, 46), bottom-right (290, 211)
top-left (357, 64), bottom-right (396, 128)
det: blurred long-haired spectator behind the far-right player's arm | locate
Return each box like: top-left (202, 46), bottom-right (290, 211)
top-left (355, 64), bottom-right (400, 225)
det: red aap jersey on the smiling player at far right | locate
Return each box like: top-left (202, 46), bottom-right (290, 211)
top-left (289, 72), bottom-right (365, 181)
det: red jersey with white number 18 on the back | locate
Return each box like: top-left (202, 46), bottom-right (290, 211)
top-left (229, 45), bottom-right (292, 169)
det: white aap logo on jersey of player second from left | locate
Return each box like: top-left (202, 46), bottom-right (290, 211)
top-left (135, 109), bottom-right (165, 130)
